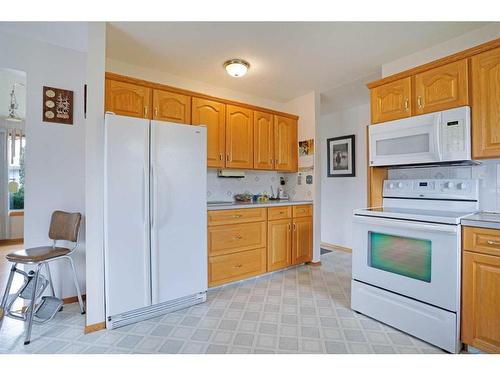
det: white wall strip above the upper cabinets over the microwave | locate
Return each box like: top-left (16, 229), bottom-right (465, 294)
top-left (382, 22), bottom-right (500, 77)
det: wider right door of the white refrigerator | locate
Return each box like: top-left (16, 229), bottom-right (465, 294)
top-left (151, 121), bottom-right (207, 304)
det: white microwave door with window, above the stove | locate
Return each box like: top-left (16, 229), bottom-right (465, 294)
top-left (368, 112), bottom-right (442, 166)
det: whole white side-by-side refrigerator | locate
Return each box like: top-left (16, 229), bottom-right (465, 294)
top-left (104, 113), bottom-right (207, 328)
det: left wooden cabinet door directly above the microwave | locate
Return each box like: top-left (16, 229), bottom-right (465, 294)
top-left (370, 77), bottom-right (412, 124)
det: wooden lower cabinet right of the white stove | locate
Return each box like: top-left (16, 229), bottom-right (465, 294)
top-left (461, 227), bottom-right (500, 353)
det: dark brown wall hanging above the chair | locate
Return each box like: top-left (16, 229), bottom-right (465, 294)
top-left (42, 86), bottom-right (73, 125)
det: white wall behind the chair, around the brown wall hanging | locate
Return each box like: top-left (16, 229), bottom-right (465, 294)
top-left (0, 31), bottom-right (86, 297)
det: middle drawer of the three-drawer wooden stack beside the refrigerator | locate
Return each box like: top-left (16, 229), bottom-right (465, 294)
top-left (208, 222), bottom-right (266, 256)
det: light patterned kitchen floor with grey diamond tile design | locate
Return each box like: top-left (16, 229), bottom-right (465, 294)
top-left (0, 251), bottom-right (442, 354)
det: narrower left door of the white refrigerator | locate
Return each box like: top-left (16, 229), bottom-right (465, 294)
top-left (104, 114), bottom-right (151, 317)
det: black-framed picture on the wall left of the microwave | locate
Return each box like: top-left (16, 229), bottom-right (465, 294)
top-left (326, 135), bottom-right (356, 177)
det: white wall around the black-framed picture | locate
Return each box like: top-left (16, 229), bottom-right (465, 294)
top-left (319, 104), bottom-right (370, 248)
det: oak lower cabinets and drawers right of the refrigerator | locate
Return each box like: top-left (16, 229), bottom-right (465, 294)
top-left (208, 204), bottom-right (313, 287)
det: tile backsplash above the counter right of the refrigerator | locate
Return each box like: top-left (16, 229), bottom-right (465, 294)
top-left (207, 169), bottom-right (313, 201)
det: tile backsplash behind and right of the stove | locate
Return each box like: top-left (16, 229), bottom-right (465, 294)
top-left (389, 159), bottom-right (500, 212)
